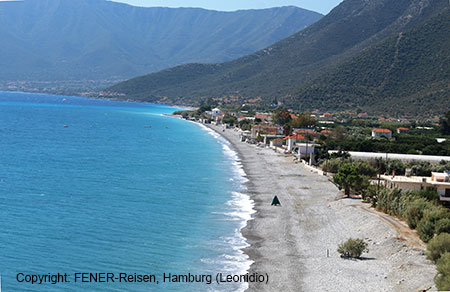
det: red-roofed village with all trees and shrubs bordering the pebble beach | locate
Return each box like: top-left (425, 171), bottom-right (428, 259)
top-left (174, 106), bottom-right (450, 291)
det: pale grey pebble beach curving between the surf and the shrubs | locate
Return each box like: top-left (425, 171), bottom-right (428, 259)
top-left (209, 126), bottom-right (436, 292)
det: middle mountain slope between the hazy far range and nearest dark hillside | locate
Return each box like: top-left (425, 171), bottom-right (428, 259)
top-left (108, 0), bottom-right (450, 116)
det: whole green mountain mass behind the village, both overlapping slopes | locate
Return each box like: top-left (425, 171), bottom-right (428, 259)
top-left (108, 0), bottom-right (450, 115)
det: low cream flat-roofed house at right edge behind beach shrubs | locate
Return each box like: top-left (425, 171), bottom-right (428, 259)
top-left (381, 172), bottom-right (450, 202)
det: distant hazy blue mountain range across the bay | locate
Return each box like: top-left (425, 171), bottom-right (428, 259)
top-left (0, 0), bottom-right (323, 80)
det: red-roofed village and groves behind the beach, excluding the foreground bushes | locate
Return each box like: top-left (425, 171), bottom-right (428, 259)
top-left (178, 106), bottom-right (450, 198)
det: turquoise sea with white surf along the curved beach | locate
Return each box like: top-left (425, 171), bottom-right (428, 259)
top-left (0, 92), bottom-right (252, 292)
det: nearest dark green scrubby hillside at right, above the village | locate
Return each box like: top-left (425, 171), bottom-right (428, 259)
top-left (290, 9), bottom-right (450, 115)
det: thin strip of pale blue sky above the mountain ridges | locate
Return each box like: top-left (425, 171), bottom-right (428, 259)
top-left (113, 0), bottom-right (342, 14)
